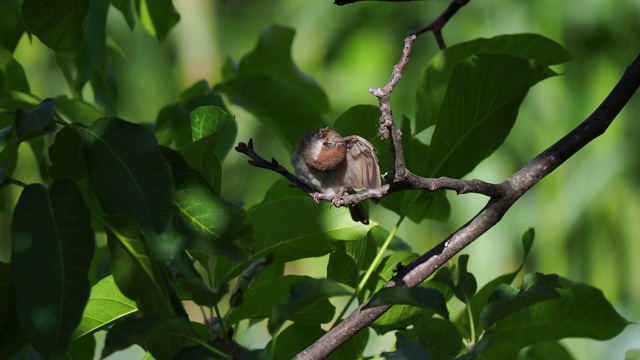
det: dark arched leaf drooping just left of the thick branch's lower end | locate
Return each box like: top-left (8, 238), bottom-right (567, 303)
top-left (267, 278), bottom-right (349, 335)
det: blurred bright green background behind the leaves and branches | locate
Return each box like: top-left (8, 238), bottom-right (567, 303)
top-left (8, 0), bottom-right (640, 359)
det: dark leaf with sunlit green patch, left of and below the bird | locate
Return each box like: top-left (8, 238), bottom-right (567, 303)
top-left (162, 148), bottom-right (248, 261)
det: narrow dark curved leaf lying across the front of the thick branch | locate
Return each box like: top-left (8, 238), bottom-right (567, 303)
top-left (365, 285), bottom-right (449, 319)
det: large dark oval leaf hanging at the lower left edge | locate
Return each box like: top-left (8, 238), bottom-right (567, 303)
top-left (11, 180), bottom-right (95, 358)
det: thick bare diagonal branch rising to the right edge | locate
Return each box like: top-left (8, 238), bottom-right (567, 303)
top-left (295, 55), bottom-right (640, 359)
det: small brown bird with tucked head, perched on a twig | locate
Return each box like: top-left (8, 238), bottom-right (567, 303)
top-left (291, 128), bottom-right (380, 224)
